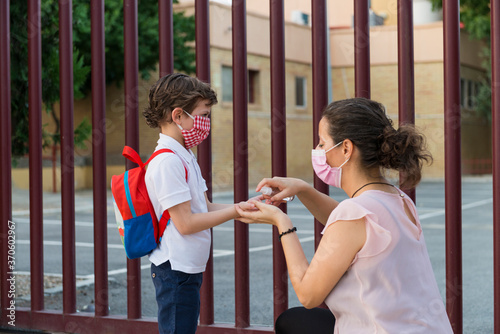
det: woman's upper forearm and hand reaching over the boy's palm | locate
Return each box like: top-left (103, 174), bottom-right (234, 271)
top-left (257, 177), bottom-right (339, 225)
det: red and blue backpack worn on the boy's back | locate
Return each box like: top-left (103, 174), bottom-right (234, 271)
top-left (111, 146), bottom-right (188, 259)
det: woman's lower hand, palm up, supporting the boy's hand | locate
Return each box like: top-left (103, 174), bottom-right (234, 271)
top-left (235, 201), bottom-right (291, 227)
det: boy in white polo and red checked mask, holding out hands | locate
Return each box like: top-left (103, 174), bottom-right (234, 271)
top-left (143, 73), bottom-right (254, 334)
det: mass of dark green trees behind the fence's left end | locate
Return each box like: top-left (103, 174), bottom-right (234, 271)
top-left (10, 0), bottom-right (195, 158)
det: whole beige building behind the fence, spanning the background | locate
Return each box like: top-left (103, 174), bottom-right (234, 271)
top-left (13, 0), bottom-right (491, 192)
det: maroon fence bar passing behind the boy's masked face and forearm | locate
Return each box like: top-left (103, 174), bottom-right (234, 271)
top-left (195, 0), bottom-right (214, 325)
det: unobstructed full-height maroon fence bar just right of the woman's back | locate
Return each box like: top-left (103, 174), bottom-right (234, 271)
top-left (443, 0), bottom-right (463, 334)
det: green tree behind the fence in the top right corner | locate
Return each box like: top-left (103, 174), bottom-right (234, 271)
top-left (431, 0), bottom-right (491, 121)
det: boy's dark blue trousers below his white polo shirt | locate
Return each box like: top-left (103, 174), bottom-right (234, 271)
top-left (151, 261), bottom-right (203, 334)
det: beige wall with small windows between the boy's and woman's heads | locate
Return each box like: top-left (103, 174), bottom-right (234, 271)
top-left (211, 48), bottom-right (313, 191)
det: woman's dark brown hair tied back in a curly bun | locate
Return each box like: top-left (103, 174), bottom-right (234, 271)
top-left (323, 98), bottom-right (432, 188)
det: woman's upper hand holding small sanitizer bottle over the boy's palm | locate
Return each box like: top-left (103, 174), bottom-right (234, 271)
top-left (256, 176), bottom-right (308, 206)
